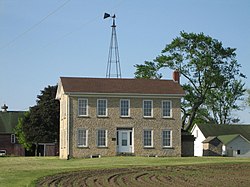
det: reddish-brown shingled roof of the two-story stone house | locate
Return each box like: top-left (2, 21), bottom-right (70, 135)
top-left (61, 77), bottom-right (184, 95)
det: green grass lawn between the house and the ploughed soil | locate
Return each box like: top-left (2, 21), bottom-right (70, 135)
top-left (0, 157), bottom-right (250, 187)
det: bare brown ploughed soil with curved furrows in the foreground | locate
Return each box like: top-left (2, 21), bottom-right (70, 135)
top-left (37, 164), bottom-right (250, 187)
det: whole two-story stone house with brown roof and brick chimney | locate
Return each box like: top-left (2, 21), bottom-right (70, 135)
top-left (56, 72), bottom-right (184, 159)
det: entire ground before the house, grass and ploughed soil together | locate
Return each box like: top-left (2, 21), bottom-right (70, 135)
top-left (0, 157), bottom-right (250, 187)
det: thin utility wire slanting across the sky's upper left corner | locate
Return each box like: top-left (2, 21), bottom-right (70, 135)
top-left (0, 0), bottom-right (71, 50)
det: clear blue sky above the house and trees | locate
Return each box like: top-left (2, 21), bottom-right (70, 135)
top-left (0, 0), bottom-right (250, 123)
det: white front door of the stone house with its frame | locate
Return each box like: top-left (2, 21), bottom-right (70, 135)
top-left (117, 130), bottom-right (133, 153)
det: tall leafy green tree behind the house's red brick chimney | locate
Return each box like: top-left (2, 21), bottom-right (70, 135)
top-left (135, 31), bottom-right (244, 129)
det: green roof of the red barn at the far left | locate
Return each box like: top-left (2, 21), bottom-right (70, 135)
top-left (0, 111), bottom-right (25, 134)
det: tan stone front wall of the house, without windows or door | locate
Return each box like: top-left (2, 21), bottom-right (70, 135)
top-left (67, 96), bottom-right (181, 158)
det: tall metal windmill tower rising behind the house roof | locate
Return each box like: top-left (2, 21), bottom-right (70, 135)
top-left (103, 13), bottom-right (121, 78)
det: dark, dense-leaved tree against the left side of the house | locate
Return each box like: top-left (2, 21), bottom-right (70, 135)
top-left (15, 86), bottom-right (60, 155)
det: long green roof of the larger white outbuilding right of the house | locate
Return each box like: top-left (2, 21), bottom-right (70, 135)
top-left (196, 124), bottom-right (250, 141)
